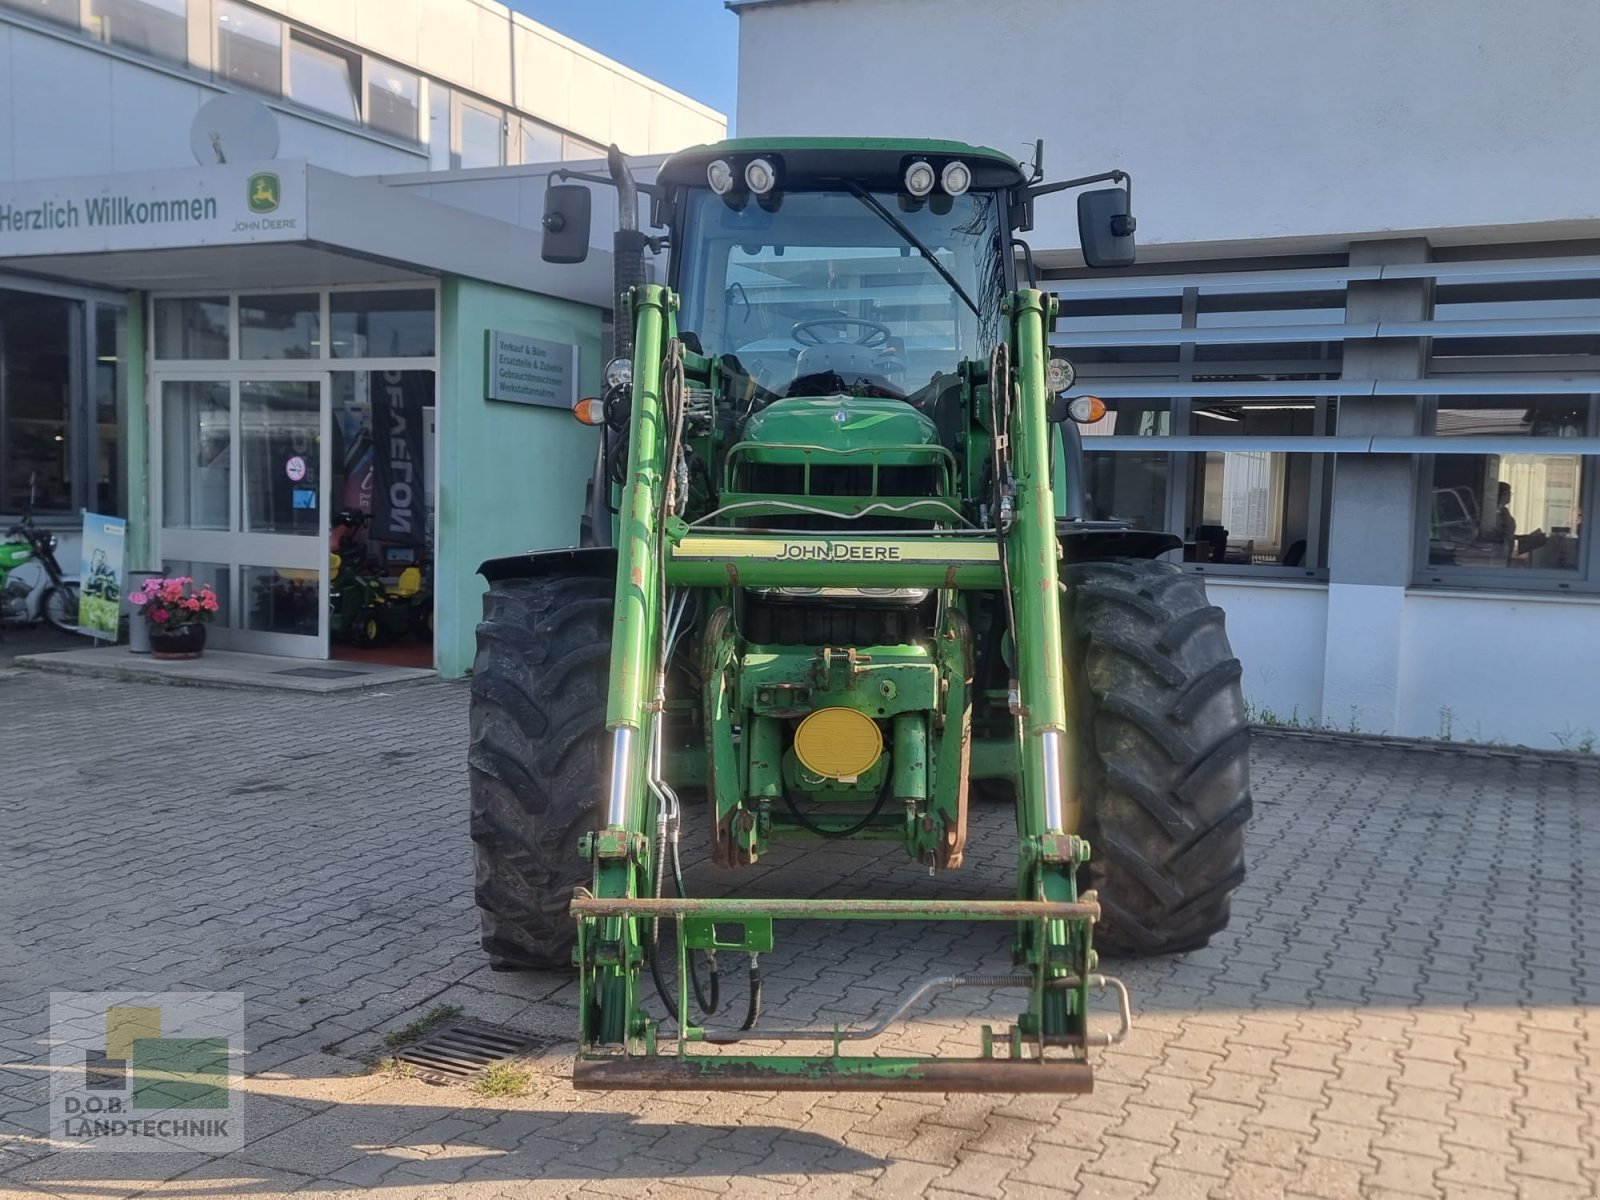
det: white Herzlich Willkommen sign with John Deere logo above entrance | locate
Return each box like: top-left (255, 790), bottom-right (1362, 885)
top-left (0, 162), bottom-right (306, 258)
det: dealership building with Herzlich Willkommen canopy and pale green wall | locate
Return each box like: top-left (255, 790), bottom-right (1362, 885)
top-left (0, 0), bottom-right (726, 675)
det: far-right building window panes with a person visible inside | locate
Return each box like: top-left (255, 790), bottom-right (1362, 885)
top-left (1422, 395), bottom-right (1594, 582)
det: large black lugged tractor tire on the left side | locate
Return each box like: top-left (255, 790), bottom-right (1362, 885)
top-left (467, 578), bottom-right (613, 971)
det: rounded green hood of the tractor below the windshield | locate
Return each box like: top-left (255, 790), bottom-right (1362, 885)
top-left (741, 395), bottom-right (939, 466)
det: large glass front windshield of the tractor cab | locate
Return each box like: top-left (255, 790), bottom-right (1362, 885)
top-left (678, 189), bottom-right (1005, 398)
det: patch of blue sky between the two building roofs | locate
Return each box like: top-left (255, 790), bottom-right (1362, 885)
top-left (507, 0), bottom-right (739, 131)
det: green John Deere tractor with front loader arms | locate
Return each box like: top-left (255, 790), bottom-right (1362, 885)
top-left (469, 139), bottom-right (1250, 1093)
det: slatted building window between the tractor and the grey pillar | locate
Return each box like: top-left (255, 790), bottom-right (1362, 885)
top-left (1054, 270), bottom-right (1344, 576)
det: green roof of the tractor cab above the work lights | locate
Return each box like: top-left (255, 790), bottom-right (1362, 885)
top-left (656, 138), bottom-right (1027, 189)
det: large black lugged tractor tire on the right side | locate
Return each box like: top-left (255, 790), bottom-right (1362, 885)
top-left (1064, 558), bottom-right (1250, 955)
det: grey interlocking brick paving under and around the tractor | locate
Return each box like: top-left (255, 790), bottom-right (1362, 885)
top-left (0, 675), bottom-right (1600, 1200)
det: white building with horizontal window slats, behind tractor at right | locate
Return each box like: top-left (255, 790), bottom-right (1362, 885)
top-left (730, 0), bottom-right (1600, 749)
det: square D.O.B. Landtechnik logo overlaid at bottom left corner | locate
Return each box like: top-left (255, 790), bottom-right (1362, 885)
top-left (50, 992), bottom-right (245, 1150)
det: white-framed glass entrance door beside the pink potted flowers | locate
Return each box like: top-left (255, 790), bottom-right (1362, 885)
top-left (152, 374), bottom-right (331, 658)
